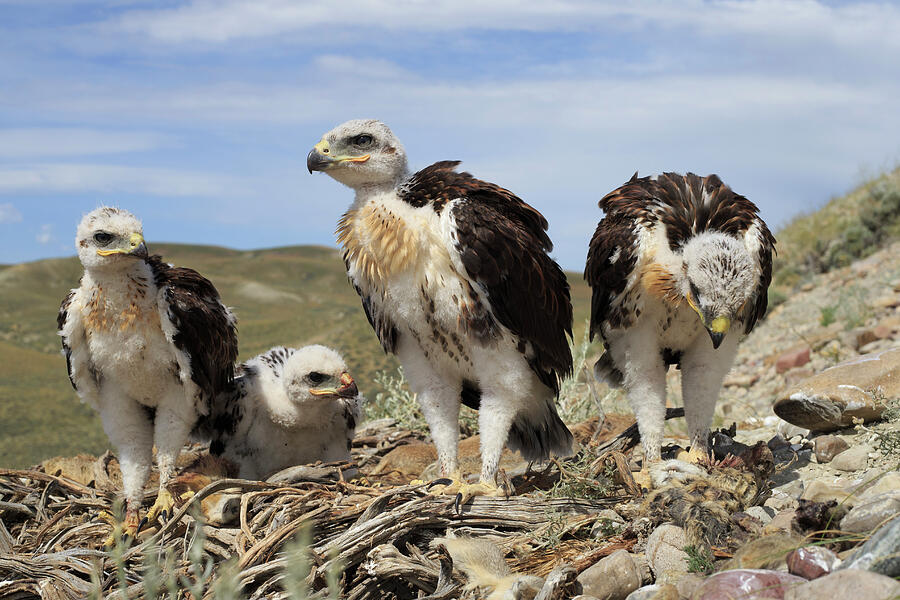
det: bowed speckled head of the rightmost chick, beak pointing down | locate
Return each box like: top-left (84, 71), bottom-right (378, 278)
top-left (682, 232), bottom-right (757, 348)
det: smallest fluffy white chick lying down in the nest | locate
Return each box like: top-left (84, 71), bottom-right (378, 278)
top-left (200, 346), bottom-right (365, 479)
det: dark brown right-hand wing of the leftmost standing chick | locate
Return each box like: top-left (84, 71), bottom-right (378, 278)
top-left (148, 256), bottom-right (238, 400)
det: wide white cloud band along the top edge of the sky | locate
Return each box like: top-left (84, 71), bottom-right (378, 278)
top-left (104, 0), bottom-right (900, 54)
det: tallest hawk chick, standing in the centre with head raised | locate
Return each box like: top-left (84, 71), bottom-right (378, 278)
top-left (307, 120), bottom-right (572, 502)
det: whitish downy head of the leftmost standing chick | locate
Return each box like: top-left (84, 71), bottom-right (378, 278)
top-left (75, 206), bottom-right (147, 269)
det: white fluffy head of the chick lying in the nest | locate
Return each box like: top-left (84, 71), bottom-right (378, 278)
top-left (282, 345), bottom-right (359, 408)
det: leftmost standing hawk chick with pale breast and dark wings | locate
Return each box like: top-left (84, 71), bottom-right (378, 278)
top-left (57, 207), bottom-right (238, 534)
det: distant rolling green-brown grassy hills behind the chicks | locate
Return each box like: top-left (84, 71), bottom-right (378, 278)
top-left (0, 244), bottom-right (590, 467)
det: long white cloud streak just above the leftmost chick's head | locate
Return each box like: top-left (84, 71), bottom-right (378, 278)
top-left (0, 164), bottom-right (246, 197)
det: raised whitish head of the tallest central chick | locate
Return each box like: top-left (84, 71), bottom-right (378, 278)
top-left (306, 119), bottom-right (407, 189)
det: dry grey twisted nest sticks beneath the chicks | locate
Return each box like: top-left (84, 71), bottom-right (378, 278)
top-left (0, 418), bottom-right (634, 600)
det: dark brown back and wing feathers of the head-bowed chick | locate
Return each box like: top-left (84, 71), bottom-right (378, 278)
top-left (585, 173), bottom-right (775, 334)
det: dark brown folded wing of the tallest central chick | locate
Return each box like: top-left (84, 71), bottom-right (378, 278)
top-left (401, 161), bottom-right (572, 392)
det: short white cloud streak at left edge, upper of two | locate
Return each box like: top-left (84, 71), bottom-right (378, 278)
top-left (0, 127), bottom-right (166, 159)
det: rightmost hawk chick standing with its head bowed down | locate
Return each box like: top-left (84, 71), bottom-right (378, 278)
top-left (584, 173), bottom-right (775, 482)
